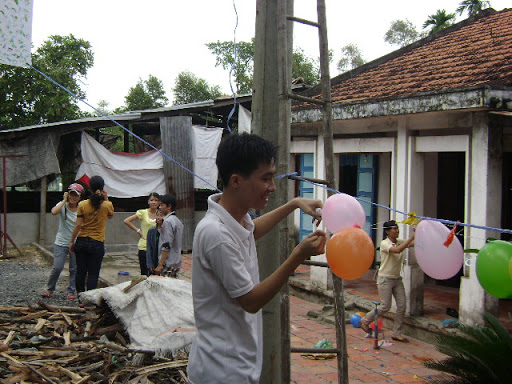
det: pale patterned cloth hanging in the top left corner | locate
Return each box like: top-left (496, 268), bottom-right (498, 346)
top-left (0, 0), bottom-right (33, 67)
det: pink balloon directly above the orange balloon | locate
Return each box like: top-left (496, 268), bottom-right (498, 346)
top-left (322, 193), bottom-right (366, 233)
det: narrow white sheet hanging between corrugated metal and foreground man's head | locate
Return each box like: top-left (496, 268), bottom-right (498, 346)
top-left (192, 125), bottom-right (223, 189)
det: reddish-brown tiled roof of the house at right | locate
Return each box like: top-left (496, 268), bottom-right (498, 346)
top-left (300, 9), bottom-right (512, 108)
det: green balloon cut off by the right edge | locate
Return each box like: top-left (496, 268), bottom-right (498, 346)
top-left (476, 240), bottom-right (512, 299)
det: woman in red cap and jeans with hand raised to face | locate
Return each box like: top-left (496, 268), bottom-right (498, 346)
top-left (41, 183), bottom-right (84, 300)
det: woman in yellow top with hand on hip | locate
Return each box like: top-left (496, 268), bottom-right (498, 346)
top-left (124, 192), bottom-right (160, 276)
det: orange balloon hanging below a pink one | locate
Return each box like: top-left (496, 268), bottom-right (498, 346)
top-left (326, 227), bottom-right (375, 279)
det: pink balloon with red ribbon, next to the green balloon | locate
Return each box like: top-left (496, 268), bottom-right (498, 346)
top-left (414, 220), bottom-right (464, 280)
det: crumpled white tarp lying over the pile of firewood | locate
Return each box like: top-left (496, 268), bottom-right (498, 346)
top-left (80, 276), bottom-right (196, 353)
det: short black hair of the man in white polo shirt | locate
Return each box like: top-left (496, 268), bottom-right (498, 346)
top-left (216, 133), bottom-right (276, 186)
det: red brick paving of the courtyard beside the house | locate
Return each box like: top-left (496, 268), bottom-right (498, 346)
top-left (180, 255), bottom-right (450, 384)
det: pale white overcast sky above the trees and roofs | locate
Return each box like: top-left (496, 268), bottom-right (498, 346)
top-left (32, 0), bottom-right (510, 109)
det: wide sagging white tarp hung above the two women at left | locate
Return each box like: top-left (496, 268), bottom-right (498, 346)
top-left (76, 132), bottom-right (165, 198)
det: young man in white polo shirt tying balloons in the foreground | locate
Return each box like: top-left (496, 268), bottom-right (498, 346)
top-left (188, 134), bottom-right (325, 384)
